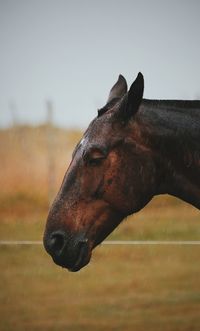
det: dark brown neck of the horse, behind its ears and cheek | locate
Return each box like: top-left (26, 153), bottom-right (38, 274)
top-left (140, 100), bottom-right (200, 209)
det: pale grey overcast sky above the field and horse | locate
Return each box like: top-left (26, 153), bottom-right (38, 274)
top-left (0, 0), bottom-right (200, 128)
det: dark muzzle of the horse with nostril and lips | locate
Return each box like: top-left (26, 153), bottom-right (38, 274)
top-left (44, 231), bottom-right (91, 272)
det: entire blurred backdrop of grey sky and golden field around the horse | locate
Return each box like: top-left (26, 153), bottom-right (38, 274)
top-left (0, 0), bottom-right (200, 331)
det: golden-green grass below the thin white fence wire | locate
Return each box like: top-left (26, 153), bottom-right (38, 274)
top-left (0, 246), bottom-right (200, 331)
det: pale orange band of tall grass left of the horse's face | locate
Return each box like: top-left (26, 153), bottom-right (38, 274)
top-left (0, 126), bottom-right (81, 196)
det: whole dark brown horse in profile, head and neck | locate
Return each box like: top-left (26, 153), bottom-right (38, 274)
top-left (44, 73), bottom-right (200, 271)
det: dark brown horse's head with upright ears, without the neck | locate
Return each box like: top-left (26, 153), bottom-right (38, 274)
top-left (44, 73), bottom-right (155, 271)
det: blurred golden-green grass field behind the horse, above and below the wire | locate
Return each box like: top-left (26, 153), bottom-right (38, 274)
top-left (0, 127), bottom-right (200, 331)
